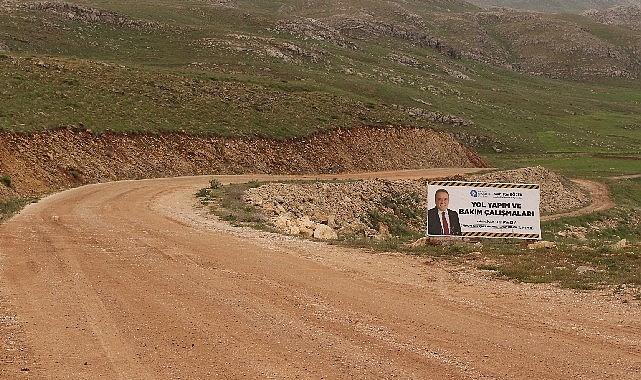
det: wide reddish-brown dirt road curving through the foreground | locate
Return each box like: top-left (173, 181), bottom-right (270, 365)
top-left (0, 172), bottom-right (641, 379)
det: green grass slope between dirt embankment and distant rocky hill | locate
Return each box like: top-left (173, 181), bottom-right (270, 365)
top-left (0, 0), bottom-right (641, 159)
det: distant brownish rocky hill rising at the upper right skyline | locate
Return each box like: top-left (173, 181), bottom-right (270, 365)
top-left (264, 4), bottom-right (641, 78)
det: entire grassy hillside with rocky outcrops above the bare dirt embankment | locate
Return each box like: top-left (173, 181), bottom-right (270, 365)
top-left (0, 0), bottom-right (641, 175)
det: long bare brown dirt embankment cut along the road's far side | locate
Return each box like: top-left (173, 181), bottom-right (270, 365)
top-left (0, 127), bottom-right (487, 199)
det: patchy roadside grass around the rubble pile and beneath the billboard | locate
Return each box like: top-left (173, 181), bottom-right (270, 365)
top-left (198, 178), bottom-right (641, 294)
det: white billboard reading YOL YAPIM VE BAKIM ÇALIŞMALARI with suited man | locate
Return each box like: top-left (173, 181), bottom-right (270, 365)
top-left (427, 181), bottom-right (541, 239)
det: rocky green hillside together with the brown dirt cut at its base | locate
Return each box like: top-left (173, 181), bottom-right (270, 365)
top-left (0, 0), bottom-right (641, 214)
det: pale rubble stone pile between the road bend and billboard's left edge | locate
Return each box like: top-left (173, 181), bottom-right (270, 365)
top-left (245, 179), bottom-right (427, 239)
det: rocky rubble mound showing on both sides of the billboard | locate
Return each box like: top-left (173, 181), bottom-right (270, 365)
top-left (245, 167), bottom-right (590, 238)
